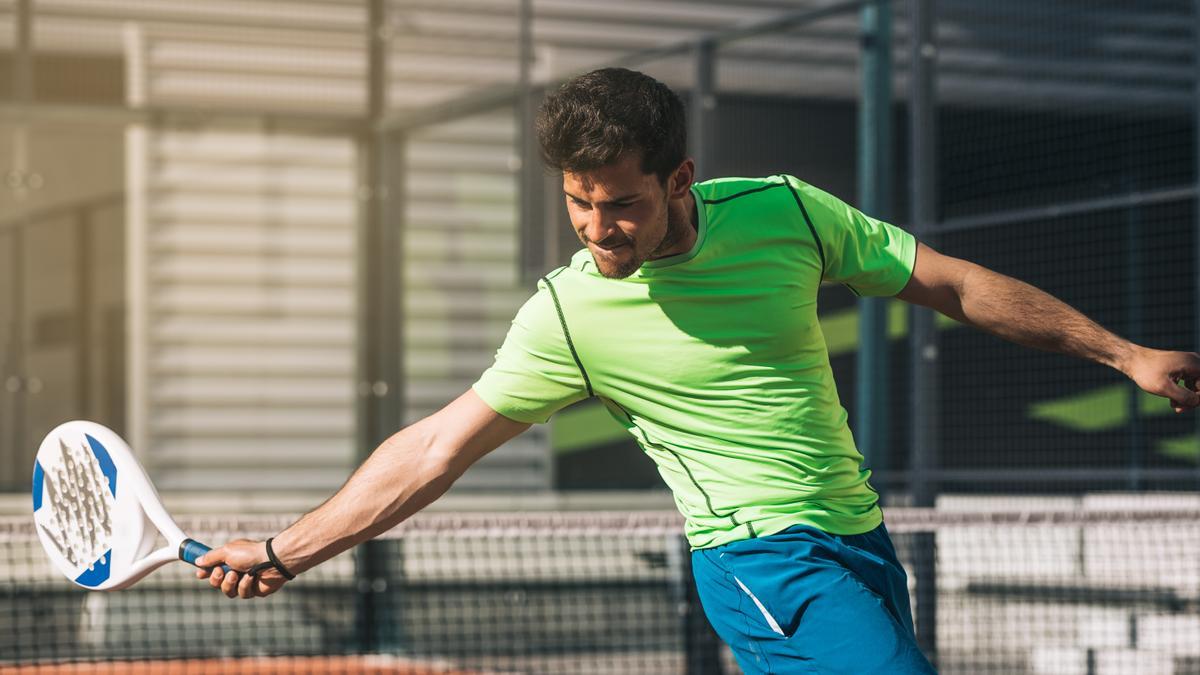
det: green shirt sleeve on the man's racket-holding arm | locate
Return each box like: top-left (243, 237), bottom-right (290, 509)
top-left (472, 281), bottom-right (588, 424)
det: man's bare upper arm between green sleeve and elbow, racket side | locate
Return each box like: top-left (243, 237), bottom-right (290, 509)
top-left (424, 389), bottom-right (530, 473)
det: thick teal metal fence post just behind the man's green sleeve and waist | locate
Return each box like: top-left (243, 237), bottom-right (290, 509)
top-left (854, 0), bottom-right (892, 497)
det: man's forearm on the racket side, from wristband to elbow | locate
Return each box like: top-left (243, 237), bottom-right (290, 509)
top-left (272, 420), bottom-right (461, 574)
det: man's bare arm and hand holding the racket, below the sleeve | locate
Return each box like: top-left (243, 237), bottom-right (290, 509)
top-left (197, 389), bottom-right (529, 598)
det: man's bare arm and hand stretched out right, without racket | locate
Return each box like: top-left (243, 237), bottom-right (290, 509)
top-left (896, 243), bottom-right (1200, 412)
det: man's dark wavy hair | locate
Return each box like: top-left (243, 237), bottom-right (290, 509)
top-left (535, 68), bottom-right (688, 185)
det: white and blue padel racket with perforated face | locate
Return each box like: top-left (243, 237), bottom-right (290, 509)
top-left (34, 420), bottom-right (229, 591)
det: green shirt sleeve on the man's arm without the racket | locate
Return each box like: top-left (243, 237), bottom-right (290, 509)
top-left (786, 177), bottom-right (917, 295)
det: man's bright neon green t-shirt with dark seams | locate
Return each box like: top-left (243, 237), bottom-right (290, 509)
top-left (474, 175), bottom-right (917, 548)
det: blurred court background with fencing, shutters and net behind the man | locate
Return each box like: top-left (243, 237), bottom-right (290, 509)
top-left (0, 0), bottom-right (1200, 674)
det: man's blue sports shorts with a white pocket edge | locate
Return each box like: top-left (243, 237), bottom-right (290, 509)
top-left (691, 516), bottom-right (936, 675)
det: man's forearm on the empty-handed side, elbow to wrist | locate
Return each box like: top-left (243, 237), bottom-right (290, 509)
top-left (946, 265), bottom-right (1141, 372)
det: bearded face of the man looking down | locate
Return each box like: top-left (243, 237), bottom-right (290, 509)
top-left (563, 153), bottom-right (674, 279)
